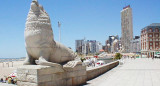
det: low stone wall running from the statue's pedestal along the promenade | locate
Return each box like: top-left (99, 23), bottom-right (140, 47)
top-left (87, 61), bottom-right (119, 80)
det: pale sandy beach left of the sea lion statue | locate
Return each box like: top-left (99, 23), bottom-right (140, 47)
top-left (0, 61), bottom-right (23, 78)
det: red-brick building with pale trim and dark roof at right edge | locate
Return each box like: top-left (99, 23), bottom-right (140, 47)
top-left (141, 23), bottom-right (160, 57)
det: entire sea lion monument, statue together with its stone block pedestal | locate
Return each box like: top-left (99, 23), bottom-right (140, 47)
top-left (17, 0), bottom-right (87, 86)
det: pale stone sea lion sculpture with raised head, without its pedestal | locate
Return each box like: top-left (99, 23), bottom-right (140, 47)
top-left (24, 0), bottom-right (76, 66)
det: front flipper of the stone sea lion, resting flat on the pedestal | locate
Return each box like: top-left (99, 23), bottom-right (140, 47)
top-left (35, 56), bottom-right (62, 68)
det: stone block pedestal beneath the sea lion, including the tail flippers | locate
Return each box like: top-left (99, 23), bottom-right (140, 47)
top-left (17, 61), bottom-right (86, 86)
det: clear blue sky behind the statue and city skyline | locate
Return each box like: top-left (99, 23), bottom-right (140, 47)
top-left (0, 0), bottom-right (160, 58)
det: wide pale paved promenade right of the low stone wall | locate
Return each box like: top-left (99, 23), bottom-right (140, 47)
top-left (84, 58), bottom-right (160, 86)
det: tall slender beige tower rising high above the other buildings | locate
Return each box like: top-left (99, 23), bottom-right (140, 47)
top-left (121, 5), bottom-right (133, 53)
